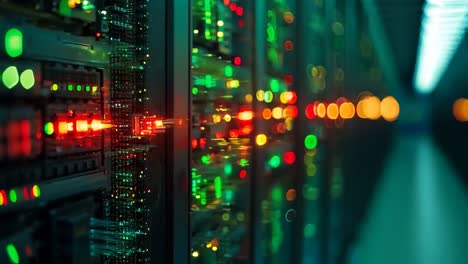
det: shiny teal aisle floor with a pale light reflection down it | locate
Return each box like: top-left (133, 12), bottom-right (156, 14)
top-left (348, 134), bottom-right (468, 264)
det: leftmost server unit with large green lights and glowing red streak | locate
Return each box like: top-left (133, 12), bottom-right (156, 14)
top-left (0, 1), bottom-right (111, 263)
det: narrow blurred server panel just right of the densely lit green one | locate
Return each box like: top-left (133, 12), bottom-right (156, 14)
top-left (255, 1), bottom-right (300, 263)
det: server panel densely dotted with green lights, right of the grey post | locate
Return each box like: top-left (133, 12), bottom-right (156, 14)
top-left (190, 0), bottom-right (254, 263)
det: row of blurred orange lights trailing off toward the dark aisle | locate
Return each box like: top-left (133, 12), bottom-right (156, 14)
top-left (305, 96), bottom-right (400, 122)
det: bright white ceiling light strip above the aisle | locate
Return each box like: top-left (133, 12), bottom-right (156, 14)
top-left (414, 0), bottom-right (468, 94)
